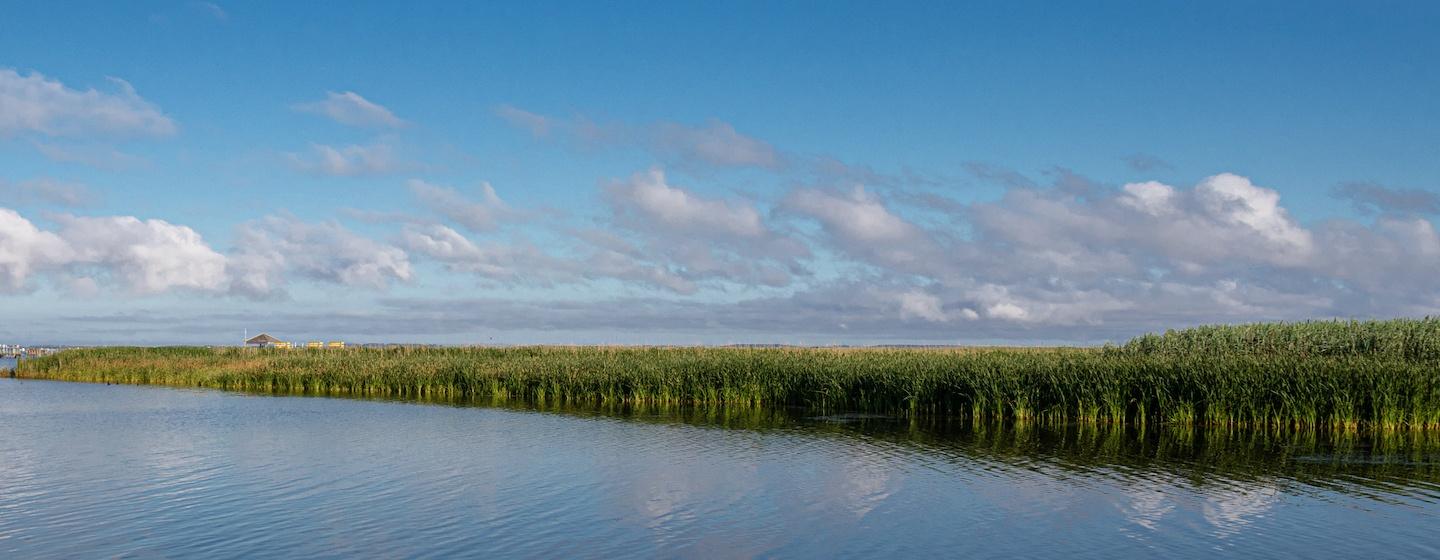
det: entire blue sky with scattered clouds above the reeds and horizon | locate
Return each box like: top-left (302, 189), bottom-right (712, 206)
top-left (0, 1), bottom-right (1440, 344)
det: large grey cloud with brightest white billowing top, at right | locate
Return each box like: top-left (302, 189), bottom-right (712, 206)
top-left (968, 169), bottom-right (1316, 276)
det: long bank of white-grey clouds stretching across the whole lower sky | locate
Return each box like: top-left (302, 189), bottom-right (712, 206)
top-left (11, 154), bottom-right (1440, 343)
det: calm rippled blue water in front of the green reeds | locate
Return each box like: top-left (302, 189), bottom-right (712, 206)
top-left (0, 379), bottom-right (1440, 559)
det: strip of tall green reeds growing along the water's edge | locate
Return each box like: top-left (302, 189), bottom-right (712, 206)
top-left (14, 318), bottom-right (1440, 430)
